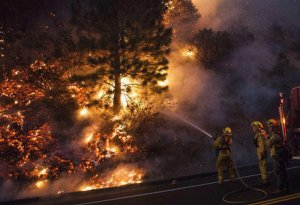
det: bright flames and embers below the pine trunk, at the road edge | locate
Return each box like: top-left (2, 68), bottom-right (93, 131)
top-left (78, 124), bottom-right (144, 191)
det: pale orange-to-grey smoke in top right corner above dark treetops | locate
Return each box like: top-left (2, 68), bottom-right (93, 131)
top-left (193, 0), bottom-right (300, 33)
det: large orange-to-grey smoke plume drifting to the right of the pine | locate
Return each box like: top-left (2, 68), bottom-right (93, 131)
top-left (169, 0), bottom-right (300, 165)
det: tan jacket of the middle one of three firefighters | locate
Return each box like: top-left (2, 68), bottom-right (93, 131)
top-left (254, 129), bottom-right (268, 160)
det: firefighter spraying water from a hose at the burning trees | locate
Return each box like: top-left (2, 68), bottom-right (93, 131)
top-left (213, 127), bottom-right (235, 184)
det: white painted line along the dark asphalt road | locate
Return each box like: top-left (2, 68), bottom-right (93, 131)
top-left (74, 166), bottom-right (300, 205)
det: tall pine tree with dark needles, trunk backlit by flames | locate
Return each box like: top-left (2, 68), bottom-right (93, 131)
top-left (72, 0), bottom-right (172, 113)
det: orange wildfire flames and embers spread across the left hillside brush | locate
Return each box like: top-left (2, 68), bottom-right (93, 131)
top-left (0, 3), bottom-right (178, 197)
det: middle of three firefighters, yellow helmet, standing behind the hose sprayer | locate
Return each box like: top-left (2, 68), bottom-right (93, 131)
top-left (251, 121), bottom-right (268, 185)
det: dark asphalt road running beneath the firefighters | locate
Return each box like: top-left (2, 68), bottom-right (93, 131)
top-left (1, 160), bottom-right (300, 205)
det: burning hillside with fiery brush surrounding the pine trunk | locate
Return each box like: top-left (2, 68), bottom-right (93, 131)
top-left (0, 1), bottom-right (190, 197)
